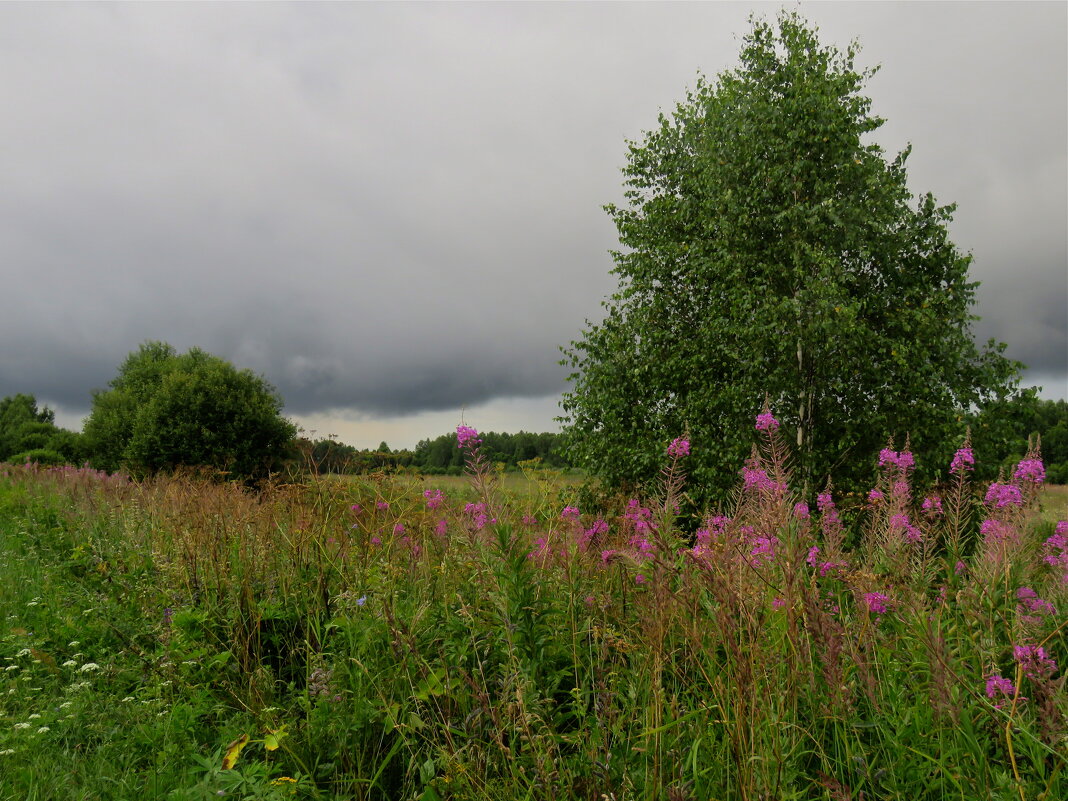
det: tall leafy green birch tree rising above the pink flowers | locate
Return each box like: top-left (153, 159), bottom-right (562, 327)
top-left (562, 13), bottom-right (1020, 501)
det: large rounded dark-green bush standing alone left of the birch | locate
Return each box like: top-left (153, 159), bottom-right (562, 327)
top-left (84, 342), bottom-right (296, 478)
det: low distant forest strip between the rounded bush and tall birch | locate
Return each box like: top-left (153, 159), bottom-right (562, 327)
top-left (298, 431), bottom-right (570, 475)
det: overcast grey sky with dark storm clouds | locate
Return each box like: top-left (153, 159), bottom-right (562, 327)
top-left (0, 2), bottom-right (1068, 449)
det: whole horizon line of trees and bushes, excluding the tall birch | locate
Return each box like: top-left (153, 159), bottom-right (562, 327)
top-left (0, 342), bottom-right (1068, 484)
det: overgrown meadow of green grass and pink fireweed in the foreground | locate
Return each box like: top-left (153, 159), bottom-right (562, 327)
top-left (0, 413), bottom-right (1068, 801)
